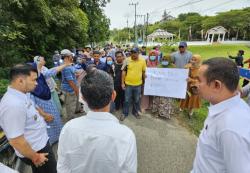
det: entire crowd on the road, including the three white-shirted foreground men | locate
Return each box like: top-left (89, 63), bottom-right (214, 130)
top-left (0, 42), bottom-right (250, 173)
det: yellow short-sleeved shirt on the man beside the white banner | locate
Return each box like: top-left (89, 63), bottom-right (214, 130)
top-left (122, 57), bottom-right (146, 86)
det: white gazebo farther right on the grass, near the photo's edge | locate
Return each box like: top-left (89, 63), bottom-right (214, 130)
top-left (205, 26), bottom-right (228, 43)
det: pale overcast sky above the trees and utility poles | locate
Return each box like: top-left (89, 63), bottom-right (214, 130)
top-left (104, 0), bottom-right (250, 29)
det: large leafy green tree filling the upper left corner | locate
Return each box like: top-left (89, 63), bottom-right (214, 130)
top-left (0, 0), bottom-right (88, 67)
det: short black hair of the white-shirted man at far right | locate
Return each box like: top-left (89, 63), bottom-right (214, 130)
top-left (202, 57), bottom-right (240, 92)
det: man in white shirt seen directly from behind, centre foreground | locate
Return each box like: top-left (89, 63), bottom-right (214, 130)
top-left (57, 69), bottom-right (137, 173)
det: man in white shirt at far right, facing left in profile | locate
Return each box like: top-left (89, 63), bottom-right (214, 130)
top-left (192, 58), bottom-right (250, 173)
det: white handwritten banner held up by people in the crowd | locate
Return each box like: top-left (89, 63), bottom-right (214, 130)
top-left (144, 68), bottom-right (188, 99)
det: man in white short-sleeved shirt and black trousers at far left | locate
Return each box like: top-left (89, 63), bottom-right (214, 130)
top-left (0, 65), bottom-right (56, 173)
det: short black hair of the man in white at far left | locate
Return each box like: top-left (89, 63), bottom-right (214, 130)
top-left (9, 64), bottom-right (37, 81)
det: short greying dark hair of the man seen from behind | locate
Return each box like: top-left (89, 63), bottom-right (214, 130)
top-left (81, 69), bottom-right (114, 109)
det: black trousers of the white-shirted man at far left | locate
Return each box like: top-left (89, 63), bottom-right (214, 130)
top-left (20, 142), bottom-right (57, 173)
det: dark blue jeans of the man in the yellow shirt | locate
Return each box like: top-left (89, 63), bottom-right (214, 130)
top-left (123, 85), bottom-right (141, 116)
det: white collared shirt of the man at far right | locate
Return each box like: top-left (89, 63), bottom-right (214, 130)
top-left (192, 95), bottom-right (250, 173)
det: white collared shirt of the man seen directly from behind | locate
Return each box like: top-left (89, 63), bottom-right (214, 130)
top-left (57, 111), bottom-right (137, 173)
